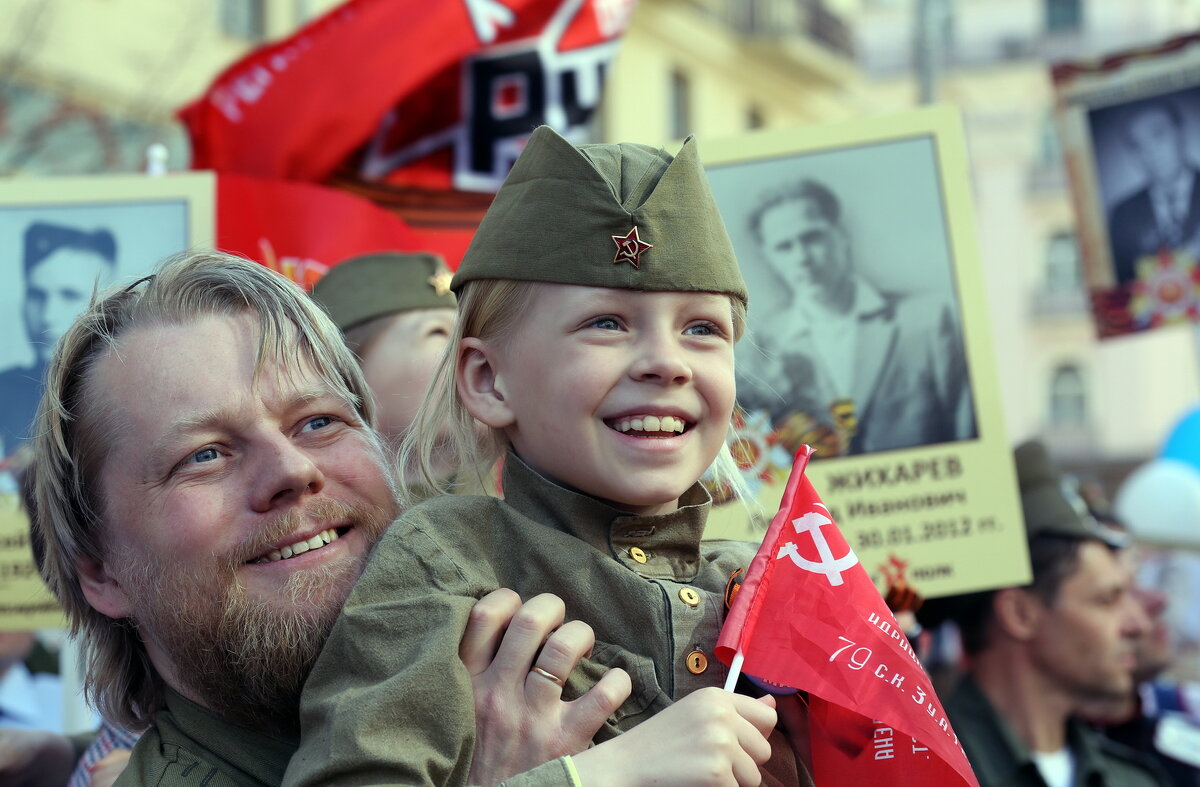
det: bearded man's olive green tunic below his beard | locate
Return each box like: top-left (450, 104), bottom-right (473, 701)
top-left (116, 689), bottom-right (298, 787)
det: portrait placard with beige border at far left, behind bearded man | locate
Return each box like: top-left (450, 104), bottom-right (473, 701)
top-left (0, 173), bottom-right (216, 630)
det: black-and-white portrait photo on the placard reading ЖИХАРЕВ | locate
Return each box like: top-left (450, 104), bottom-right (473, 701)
top-left (709, 139), bottom-right (976, 456)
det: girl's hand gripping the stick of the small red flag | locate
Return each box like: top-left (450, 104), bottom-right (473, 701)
top-left (574, 689), bottom-right (775, 787)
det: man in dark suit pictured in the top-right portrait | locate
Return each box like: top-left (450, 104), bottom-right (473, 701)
top-left (1100, 98), bottom-right (1200, 284)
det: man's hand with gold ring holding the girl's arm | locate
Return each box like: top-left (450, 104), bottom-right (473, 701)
top-left (458, 589), bottom-right (630, 785)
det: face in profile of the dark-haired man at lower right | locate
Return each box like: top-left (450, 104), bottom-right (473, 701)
top-left (1031, 541), bottom-right (1148, 701)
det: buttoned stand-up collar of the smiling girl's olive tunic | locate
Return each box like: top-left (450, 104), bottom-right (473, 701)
top-left (504, 451), bottom-right (712, 581)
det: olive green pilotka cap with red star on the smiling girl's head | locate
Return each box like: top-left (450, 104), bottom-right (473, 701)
top-left (451, 126), bottom-right (748, 301)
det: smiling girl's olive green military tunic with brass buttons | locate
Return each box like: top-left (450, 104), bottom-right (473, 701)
top-left (286, 453), bottom-right (808, 785)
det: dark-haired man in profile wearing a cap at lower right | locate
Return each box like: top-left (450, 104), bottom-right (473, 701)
top-left (918, 443), bottom-right (1169, 787)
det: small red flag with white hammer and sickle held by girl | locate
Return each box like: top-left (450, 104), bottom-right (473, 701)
top-left (716, 446), bottom-right (978, 787)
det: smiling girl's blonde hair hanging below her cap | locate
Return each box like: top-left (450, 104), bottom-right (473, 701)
top-left (400, 278), bottom-right (752, 505)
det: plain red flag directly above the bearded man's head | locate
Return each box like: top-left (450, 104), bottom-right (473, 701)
top-left (215, 174), bottom-right (427, 289)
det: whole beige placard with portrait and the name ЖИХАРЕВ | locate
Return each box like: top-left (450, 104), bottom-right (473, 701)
top-left (701, 107), bottom-right (1030, 597)
